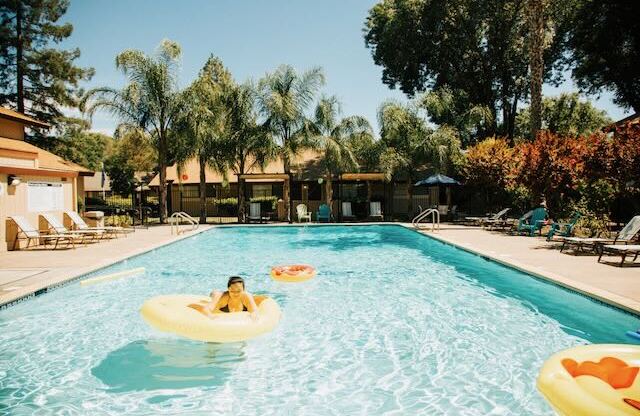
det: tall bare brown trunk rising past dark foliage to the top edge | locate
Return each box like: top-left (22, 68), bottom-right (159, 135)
top-left (527, 0), bottom-right (544, 138)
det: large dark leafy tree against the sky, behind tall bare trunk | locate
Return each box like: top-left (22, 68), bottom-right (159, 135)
top-left (365, 0), bottom-right (571, 140)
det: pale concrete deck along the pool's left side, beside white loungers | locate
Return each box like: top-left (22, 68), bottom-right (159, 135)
top-left (0, 225), bottom-right (211, 306)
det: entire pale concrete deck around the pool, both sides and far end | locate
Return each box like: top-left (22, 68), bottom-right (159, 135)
top-left (0, 223), bottom-right (640, 314)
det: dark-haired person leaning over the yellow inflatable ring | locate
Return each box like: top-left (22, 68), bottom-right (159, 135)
top-left (189, 276), bottom-right (262, 319)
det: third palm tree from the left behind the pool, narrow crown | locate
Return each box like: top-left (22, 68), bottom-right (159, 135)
top-left (218, 82), bottom-right (277, 222)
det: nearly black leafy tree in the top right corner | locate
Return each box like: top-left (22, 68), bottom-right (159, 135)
top-left (568, 0), bottom-right (640, 112)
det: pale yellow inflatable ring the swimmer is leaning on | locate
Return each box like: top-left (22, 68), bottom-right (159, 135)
top-left (140, 295), bottom-right (280, 342)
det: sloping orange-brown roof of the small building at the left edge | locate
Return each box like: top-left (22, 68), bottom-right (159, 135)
top-left (0, 137), bottom-right (93, 176)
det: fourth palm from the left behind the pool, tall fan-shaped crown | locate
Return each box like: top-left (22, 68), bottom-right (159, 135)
top-left (258, 65), bottom-right (324, 222)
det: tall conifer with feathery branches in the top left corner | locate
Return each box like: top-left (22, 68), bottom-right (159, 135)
top-left (0, 0), bottom-right (94, 130)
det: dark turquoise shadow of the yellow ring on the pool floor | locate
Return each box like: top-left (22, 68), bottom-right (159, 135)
top-left (91, 339), bottom-right (246, 393)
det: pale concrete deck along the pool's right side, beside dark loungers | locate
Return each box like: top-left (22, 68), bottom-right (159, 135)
top-left (410, 224), bottom-right (640, 313)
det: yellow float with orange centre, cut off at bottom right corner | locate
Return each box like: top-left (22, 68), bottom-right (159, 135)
top-left (538, 344), bottom-right (640, 416)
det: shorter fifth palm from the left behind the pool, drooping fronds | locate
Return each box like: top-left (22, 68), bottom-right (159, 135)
top-left (312, 96), bottom-right (371, 207)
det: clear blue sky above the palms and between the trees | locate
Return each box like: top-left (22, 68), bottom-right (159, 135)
top-left (62, 0), bottom-right (624, 134)
